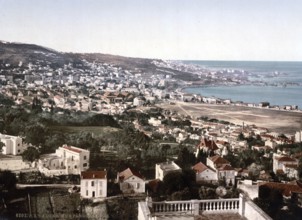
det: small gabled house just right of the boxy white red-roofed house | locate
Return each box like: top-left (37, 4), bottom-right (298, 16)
top-left (117, 168), bottom-right (145, 193)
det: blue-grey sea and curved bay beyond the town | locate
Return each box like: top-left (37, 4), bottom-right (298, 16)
top-left (182, 61), bottom-right (302, 110)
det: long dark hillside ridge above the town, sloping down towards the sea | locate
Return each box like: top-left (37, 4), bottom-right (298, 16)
top-left (0, 41), bottom-right (198, 81)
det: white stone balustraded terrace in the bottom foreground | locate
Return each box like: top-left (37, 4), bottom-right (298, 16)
top-left (138, 195), bottom-right (271, 220)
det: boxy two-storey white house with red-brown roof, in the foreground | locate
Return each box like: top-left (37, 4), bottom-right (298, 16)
top-left (81, 171), bottom-right (107, 199)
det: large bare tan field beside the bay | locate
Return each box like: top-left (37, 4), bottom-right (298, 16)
top-left (158, 102), bottom-right (302, 134)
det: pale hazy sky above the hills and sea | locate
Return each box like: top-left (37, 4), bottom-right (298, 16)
top-left (0, 0), bottom-right (302, 61)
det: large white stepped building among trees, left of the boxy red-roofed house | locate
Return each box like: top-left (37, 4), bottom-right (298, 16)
top-left (38, 145), bottom-right (90, 176)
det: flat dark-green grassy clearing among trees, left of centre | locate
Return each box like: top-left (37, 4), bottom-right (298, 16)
top-left (50, 126), bottom-right (119, 136)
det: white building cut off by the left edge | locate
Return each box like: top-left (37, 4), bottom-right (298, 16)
top-left (0, 134), bottom-right (26, 155)
